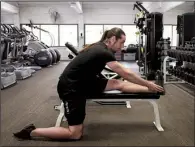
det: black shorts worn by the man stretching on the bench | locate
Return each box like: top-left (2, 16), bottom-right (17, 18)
top-left (57, 78), bottom-right (108, 126)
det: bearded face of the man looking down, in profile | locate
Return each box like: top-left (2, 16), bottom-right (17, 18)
top-left (111, 35), bottom-right (126, 52)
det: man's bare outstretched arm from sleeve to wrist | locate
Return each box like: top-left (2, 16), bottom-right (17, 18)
top-left (106, 61), bottom-right (149, 87)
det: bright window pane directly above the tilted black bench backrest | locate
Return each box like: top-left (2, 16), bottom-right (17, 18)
top-left (60, 25), bottom-right (78, 46)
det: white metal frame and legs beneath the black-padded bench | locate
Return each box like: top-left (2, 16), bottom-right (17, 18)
top-left (54, 98), bottom-right (164, 132)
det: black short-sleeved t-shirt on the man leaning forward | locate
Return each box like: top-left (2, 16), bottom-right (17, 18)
top-left (60, 42), bottom-right (116, 89)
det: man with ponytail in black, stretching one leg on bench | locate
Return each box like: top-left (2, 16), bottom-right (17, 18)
top-left (14, 28), bottom-right (163, 140)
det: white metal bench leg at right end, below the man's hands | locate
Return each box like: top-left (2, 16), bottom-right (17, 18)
top-left (150, 100), bottom-right (164, 131)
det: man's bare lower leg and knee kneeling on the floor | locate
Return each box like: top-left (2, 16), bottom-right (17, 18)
top-left (31, 125), bottom-right (83, 139)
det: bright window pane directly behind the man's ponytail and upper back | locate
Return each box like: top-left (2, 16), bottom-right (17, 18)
top-left (85, 25), bottom-right (103, 44)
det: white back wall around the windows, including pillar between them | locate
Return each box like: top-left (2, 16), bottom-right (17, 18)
top-left (1, 2), bottom-right (191, 60)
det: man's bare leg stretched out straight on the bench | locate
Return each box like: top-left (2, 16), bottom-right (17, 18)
top-left (105, 79), bottom-right (152, 93)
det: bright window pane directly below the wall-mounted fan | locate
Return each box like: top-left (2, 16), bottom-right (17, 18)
top-left (41, 25), bottom-right (58, 46)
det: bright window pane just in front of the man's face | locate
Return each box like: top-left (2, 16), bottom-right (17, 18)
top-left (122, 25), bottom-right (139, 46)
